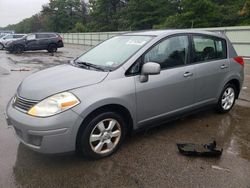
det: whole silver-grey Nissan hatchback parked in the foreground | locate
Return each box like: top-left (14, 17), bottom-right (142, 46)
top-left (6, 30), bottom-right (244, 159)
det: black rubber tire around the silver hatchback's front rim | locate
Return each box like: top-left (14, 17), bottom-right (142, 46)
top-left (76, 112), bottom-right (126, 159)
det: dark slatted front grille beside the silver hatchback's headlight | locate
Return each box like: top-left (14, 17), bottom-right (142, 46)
top-left (13, 95), bottom-right (37, 112)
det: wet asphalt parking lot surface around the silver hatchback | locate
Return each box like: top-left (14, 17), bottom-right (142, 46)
top-left (0, 45), bottom-right (250, 188)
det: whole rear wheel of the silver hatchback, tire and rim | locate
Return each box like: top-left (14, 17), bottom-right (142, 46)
top-left (217, 83), bottom-right (237, 113)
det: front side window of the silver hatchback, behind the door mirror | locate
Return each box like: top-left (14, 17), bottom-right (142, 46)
top-left (144, 36), bottom-right (188, 69)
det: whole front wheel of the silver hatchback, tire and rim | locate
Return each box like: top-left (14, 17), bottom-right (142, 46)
top-left (77, 112), bottom-right (126, 159)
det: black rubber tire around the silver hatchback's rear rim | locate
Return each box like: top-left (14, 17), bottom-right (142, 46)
top-left (216, 83), bottom-right (238, 113)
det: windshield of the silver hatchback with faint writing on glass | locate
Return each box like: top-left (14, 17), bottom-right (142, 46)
top-left (75, 35), bottom-right (152, 70)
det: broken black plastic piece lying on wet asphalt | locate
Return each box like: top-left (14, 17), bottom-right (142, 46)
top-left (177, 141), bottom-right (223, 157)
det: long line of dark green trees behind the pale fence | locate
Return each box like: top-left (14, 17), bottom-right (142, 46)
top-left (5, 0), bottom-right (250, 33)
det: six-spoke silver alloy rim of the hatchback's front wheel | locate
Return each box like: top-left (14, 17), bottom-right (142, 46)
top-left (89, 118), bottom-right (121, 154)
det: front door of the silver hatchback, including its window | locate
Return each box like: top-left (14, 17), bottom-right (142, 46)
top-left (135, 35), bottom-right (194, 126)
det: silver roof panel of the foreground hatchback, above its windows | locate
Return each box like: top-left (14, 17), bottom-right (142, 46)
top-left (124, 29), bottom-right (225, 38)
